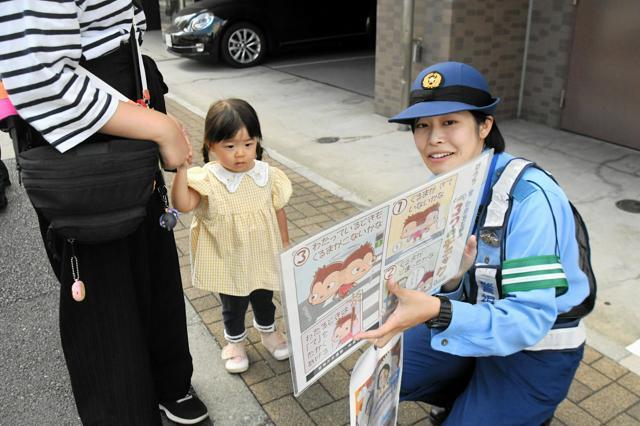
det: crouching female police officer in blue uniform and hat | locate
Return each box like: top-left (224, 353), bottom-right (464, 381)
top-left (358, 62), bottom-right (589, 425)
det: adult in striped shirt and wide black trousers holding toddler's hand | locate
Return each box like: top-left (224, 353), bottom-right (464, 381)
top-left (0, 0), bottom-right (207, 425)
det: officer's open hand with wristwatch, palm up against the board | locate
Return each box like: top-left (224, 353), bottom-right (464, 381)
top-left (355, 280), bottom-right (440, 347)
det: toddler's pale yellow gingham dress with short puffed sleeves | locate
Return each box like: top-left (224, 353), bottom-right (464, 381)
top-left (187, 160), bottom-right (291, 296)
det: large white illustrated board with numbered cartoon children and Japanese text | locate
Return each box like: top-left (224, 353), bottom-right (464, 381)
top-left (280, 151), bottom-right (493, 396)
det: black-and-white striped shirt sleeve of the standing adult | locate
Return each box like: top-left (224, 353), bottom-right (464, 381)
top-left (0, 0), bottom-right (118, 152)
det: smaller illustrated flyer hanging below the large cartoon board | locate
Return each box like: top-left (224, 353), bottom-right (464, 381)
top-left (349, 334), bottom-right (402, 426)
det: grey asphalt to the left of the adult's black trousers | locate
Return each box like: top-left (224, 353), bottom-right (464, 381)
top-left (0, 160), bottom-right (80, 425)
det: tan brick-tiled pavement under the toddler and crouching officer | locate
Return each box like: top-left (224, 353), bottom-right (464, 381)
top-left (167, 100), bottom-right (640, 426)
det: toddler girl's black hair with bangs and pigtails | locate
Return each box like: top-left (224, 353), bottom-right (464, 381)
top-left (202, 98), bottom-right (262, 163)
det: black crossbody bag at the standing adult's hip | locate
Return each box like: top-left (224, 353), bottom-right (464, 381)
top-left (12, 20), bottom-right (168, 243)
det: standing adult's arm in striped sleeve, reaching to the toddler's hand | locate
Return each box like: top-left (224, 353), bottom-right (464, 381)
top-left (0, 0), bottom-right (189, 167)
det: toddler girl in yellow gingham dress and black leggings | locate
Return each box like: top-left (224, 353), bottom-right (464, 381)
top-left (171, 99), bottom-right (291, 373)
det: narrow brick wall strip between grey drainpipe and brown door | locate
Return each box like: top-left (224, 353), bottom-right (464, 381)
top-left (521, 0), bottom-right (575, 127)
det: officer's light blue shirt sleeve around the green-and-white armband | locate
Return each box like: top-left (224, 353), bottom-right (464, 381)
top-left (431, 190), bottom-right (568, 356)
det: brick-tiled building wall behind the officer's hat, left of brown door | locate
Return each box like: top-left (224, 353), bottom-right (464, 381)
top-left (375, 0), bottom-right (575, 127)
